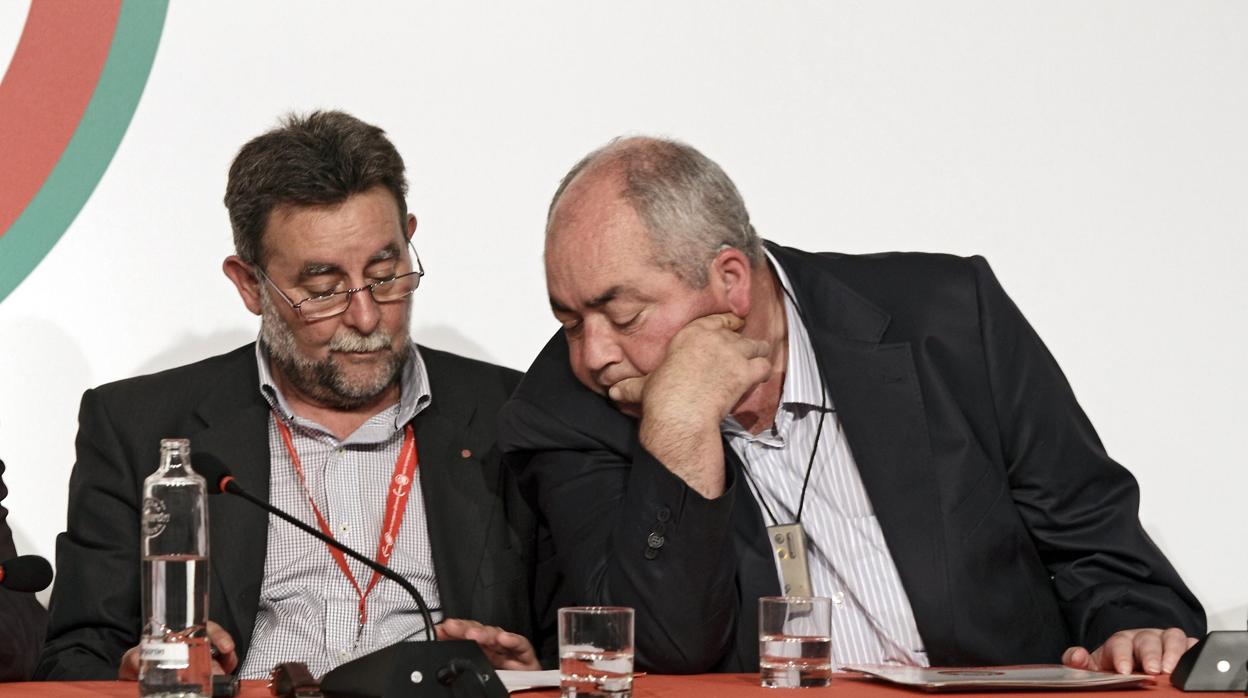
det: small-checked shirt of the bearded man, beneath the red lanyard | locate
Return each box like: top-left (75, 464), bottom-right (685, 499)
top-left (238, 342), bottom-right (441, 678)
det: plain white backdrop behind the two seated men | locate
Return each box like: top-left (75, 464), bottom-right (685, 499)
top-left (0, 0), bottom-right (1248, 628)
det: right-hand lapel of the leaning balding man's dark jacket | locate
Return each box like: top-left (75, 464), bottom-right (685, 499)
top-left (773, 247), bottom-right (953, 647)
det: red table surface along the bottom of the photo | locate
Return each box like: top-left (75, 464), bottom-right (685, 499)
top-left (0, 674), bottom-right (1183, 698)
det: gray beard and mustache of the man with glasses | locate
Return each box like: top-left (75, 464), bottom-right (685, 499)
top-left (260, 288), bottom-right (411, 411)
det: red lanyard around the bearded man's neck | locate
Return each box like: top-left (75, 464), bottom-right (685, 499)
top-left (273, 413), bottom-right (418, 632)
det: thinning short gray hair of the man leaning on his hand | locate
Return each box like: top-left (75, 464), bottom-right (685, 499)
top-left (547, 136), bottom-right (765, 288)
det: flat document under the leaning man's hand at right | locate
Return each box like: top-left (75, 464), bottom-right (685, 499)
top-left (841, 664), bottom-right (1153, 691)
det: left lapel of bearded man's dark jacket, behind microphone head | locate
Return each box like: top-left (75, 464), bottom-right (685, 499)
top-left (191, 352), bottom-right (270, 656)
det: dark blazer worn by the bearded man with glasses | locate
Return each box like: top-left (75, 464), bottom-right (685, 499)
top-left (37, 345), bottom-right (534, 679)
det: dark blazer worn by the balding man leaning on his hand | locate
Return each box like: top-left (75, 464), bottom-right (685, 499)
top-left (499, 246), bottom-right (1204, 672)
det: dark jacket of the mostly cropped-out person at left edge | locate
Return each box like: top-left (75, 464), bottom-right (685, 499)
top-left (0, 461), bottom-right (47, 681)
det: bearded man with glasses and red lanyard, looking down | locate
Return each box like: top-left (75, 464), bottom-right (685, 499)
top-left (39, 111), bottom-right (537, 679)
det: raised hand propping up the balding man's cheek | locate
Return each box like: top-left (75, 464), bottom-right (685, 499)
top-left (609, 313), bottom-right (771, 498)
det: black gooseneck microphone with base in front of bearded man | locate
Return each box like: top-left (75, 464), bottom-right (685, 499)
top-left (193, 452), bottom-right (507, 698)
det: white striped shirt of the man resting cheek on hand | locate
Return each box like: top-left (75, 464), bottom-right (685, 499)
top-left (720, 252), bottom-right (927, 666)
